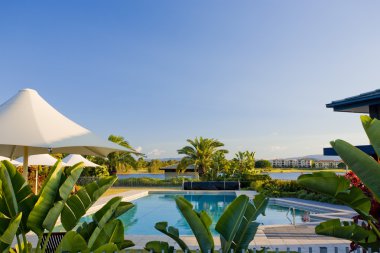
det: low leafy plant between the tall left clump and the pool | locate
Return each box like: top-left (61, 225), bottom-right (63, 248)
top-left (56, 197), bottom-right (134, 253)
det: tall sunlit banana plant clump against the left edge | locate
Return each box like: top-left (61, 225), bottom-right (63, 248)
top-left (0, 160), bottom-right (117, 253)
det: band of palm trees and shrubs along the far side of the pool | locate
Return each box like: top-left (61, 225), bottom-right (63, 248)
top-left (79, 135), bottom-right (271, 180)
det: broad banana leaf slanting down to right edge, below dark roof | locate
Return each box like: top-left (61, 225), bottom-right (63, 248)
top-left (331, 139), bottom-right (380, 201)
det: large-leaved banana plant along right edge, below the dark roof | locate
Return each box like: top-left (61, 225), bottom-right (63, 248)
top-left (298, 116), bottom-right (380, 249)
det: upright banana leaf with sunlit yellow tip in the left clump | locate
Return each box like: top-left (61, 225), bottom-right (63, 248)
top-left (27, 161), bottom-right (62, 236)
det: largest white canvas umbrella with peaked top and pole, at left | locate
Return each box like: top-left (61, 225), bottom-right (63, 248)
top-left (0, 89), bottom-right (130, 178)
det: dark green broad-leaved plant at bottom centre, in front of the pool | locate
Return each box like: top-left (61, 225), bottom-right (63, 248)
top-left (145, 194), bottom-right (268, 253)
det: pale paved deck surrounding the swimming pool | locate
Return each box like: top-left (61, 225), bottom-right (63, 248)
top-left (23, 188), bottom-right (352, 252)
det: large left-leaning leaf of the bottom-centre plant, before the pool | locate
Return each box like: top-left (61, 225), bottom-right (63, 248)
top-left (175, 196), bottom-right (214, 253)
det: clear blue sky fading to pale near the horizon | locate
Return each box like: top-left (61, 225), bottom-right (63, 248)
top-left (0, 0), bottom-right (380, 158)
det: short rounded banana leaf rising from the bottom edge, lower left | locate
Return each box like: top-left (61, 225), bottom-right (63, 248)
top-left (55, 231), bottom-right (90, 253)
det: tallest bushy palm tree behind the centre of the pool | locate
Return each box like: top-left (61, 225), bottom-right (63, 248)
top-left (177, 137), bottom-right (228, 177)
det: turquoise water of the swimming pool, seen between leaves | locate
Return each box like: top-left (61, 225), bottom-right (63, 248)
top-left (61, 192), bottom-right (320, 235)
